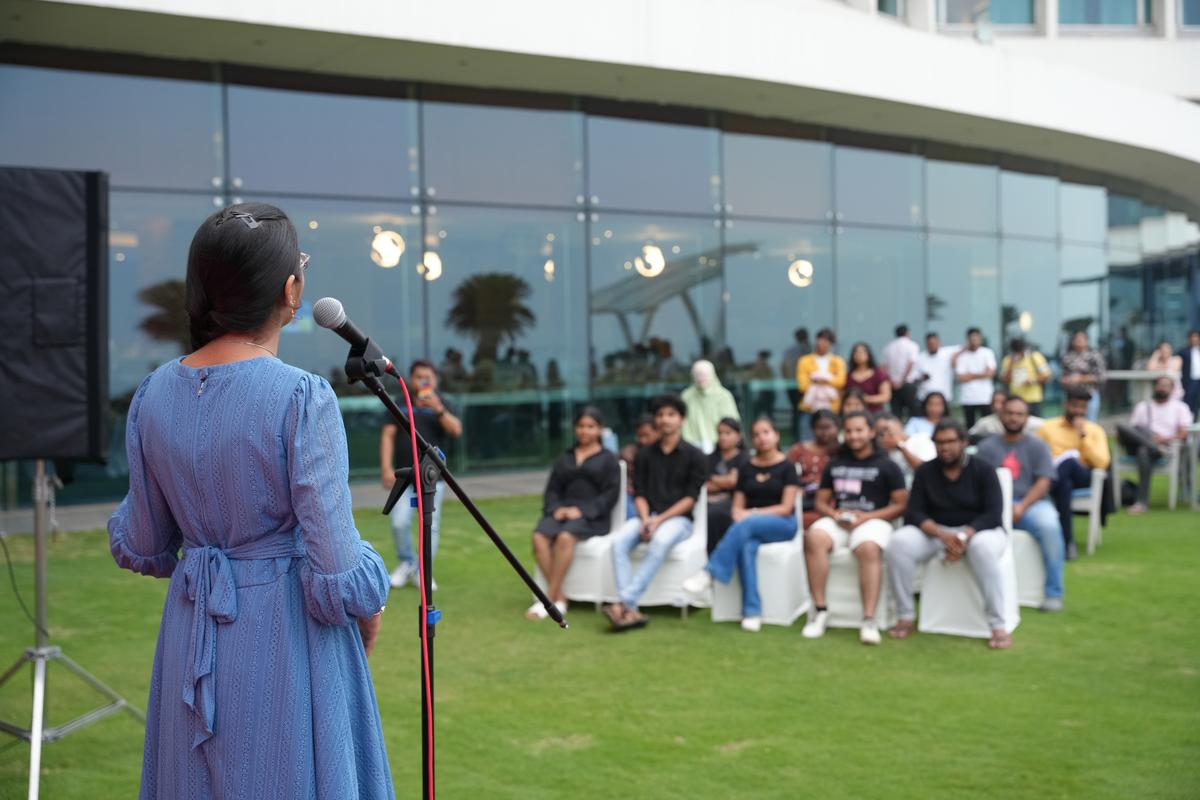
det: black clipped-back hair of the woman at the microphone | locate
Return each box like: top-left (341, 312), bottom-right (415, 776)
top-left (184, 203), bottom-right (300, 349)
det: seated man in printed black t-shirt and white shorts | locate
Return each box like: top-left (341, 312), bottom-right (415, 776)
top-left (803, 411), bottom-right (908, 644)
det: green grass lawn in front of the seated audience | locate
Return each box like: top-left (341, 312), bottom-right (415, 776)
top-left (0, 484), bottom-right (1200, 800)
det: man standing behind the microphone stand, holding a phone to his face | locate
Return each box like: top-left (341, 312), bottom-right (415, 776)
top-left (379, 360), bottom-right (462, 589)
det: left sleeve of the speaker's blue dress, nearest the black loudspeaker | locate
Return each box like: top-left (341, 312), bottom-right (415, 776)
top-left (108, 374), bottom-right (184, 578)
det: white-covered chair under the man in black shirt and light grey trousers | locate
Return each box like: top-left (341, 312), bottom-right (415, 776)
top-left (917, 467), bottom-right (1021, 639)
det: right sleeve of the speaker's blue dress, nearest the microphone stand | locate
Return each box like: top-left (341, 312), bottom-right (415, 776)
top-left (284, 375), bottom-right (390, 625)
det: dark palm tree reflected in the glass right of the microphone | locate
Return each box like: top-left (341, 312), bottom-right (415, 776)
top-left (445, 272), bottom-right (538, 363)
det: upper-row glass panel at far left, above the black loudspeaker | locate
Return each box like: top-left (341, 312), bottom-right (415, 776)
top-left (0, 66), bottom-right (223, 191)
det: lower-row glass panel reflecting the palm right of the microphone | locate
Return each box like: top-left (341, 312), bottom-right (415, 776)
top-left (426, 206), bottom-right (588, 468)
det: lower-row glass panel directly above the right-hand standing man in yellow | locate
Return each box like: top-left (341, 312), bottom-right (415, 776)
top-left (1000, 239), bottom-right (1060, 355)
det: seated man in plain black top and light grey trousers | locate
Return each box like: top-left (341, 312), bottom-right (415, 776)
top-left (887, 419), bottom-right (1013, 650)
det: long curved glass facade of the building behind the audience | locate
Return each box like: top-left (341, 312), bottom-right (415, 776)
top-left (0, 59), bottom-right (1200, 503)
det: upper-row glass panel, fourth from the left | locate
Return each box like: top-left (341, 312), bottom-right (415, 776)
top-left (588, 116), bottom-right (721, 213)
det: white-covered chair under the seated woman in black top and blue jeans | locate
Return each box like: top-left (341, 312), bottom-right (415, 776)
top-left (713, 491), bottom-right (810, 625)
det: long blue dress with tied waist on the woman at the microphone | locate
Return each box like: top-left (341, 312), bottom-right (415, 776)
top-left (108, 357), bottom-right (395, 800)
